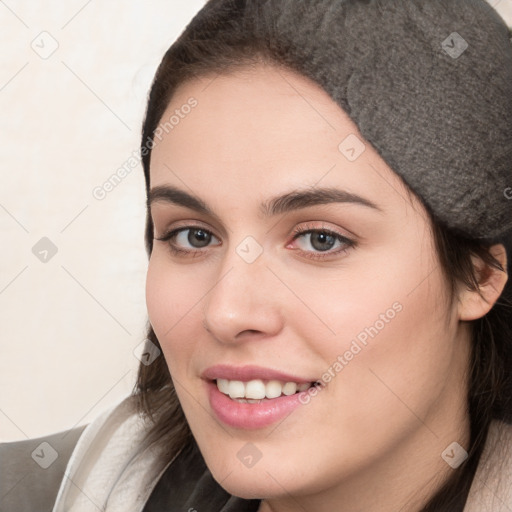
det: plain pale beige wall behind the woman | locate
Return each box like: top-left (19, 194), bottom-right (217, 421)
top-left (0, 0), bottom-right (512, 441)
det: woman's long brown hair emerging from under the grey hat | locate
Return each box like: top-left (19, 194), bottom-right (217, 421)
top-left (133, 0), bottom-right (512, 512)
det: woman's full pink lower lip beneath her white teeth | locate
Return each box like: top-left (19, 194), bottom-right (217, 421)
top-left (206, 381), bottom-right (308, 429)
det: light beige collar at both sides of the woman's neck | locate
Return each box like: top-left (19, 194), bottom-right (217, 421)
top-left (52, 396), bottom-right (512, 512)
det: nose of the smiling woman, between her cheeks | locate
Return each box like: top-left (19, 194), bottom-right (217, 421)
top-left (203, 244), bottom-right (283, 344)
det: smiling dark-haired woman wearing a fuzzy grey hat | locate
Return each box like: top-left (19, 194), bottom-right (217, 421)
top-left (2, 0), bottom-right (512, 512)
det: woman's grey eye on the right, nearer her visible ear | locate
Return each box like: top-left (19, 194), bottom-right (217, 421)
top-left (293, 222), bottom-right (355, 259)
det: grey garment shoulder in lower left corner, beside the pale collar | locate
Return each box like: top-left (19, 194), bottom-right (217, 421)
top-left (0, 425), bottom-right (87, 512)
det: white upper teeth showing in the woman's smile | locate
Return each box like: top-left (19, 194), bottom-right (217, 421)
top-left (217, 379), bottom-right (311, 403)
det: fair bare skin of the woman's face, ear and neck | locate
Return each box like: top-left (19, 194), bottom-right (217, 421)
top-left (147, 64), bottom-right (506, 512)
